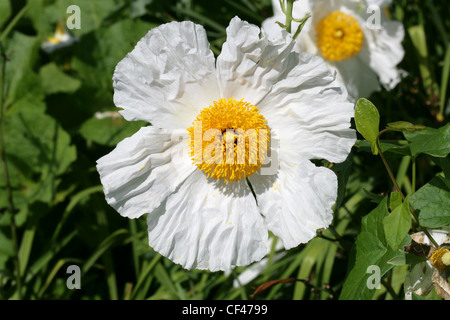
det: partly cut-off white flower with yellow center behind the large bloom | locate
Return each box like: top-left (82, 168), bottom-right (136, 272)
top-left (263, 0), bottom-right (405, 100)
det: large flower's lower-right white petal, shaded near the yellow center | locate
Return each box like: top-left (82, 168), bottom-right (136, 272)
top-left (249, 158), bottom-right (337, 249)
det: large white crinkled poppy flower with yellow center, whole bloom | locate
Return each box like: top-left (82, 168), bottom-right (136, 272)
top-left (97, 17), bottom-right (355, 271)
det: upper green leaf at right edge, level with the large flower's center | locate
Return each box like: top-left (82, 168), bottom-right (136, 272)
top-left (403, 123), bottom-right (450, 158)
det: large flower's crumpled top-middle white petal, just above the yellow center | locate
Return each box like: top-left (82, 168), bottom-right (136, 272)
top-left (217, 17), bottom-right (294, 107)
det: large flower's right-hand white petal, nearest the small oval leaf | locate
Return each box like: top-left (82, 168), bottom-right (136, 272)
top-left (260, 53), bottom-right (356, 162)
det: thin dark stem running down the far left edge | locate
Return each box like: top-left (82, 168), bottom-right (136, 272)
top-left (0, 41), bottom-right (22, 299)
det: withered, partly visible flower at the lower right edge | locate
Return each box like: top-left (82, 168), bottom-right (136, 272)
top-left (404, 230), bottom-right (450, 300)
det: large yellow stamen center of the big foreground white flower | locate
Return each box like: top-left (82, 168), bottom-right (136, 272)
top-left (187, 98), bottom-right (270, 182)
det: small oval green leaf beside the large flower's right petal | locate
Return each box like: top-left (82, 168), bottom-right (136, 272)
top-left (355, 98), bottom-right (380, 154)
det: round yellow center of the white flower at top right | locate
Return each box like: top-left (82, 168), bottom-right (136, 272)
top-left (316, 11), bottom-right (364, 61)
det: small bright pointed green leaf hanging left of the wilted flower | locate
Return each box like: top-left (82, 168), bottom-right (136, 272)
top-left (383, 199), bottom-right (411, 251)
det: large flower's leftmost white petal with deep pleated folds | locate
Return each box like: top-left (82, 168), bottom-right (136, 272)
top-left (97, 126), bottom-right (196, 218)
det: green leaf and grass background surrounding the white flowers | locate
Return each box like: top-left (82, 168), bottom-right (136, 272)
top-left (0, 0), bottom-right (450, 300)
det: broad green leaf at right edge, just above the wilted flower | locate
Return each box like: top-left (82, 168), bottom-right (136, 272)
top-left (410, 176), bottom-right (450, 228)
